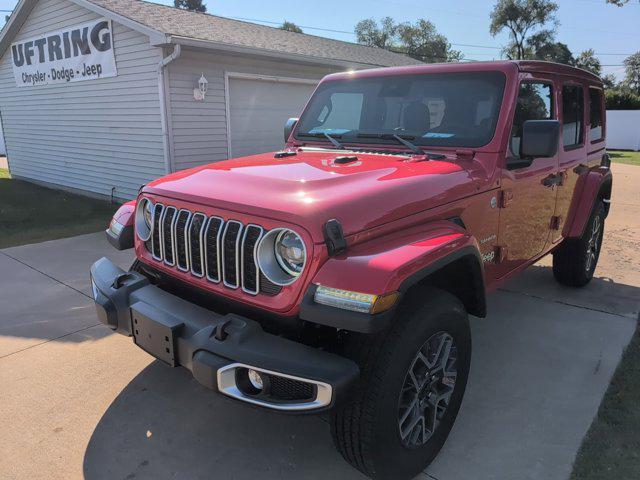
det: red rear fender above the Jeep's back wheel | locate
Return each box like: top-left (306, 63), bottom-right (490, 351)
top-left (562, 168), bottom-right (613, 238)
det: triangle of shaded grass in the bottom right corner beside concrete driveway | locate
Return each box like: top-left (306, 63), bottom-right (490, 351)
top-left (571, 320), bottom-right (640, 480)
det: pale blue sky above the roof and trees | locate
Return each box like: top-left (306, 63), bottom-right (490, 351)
top-left (0, 0), bottom-right (640, 79)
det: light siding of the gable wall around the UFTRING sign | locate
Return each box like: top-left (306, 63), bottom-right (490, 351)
top-left (0, 0), bottom-right (164, 198)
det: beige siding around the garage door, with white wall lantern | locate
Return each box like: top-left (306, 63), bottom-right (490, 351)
top-left (169, 49), bottom-right (339, 170)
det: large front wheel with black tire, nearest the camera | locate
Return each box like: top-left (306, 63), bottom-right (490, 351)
top-left (331, 287), bottom-right (471, 480)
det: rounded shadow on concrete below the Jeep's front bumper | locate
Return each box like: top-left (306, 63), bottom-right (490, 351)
top-left (83, 361), bottom-right (365, 480)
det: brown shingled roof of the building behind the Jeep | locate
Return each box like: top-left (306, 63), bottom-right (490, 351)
top-left (81, 0), bottom-right (422, 67)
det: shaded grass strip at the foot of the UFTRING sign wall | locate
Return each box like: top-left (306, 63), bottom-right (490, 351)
top-left (0, 169), bottom-right (118, 248)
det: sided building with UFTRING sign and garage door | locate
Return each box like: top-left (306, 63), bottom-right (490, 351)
top-left (0, 0), bottom-right (418, 199)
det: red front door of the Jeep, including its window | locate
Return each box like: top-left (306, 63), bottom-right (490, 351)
top-left (495, 74), bottom-right (558, 277)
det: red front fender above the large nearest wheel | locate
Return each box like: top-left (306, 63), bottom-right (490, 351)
top-left (313, 220), bottom-right (486, 316)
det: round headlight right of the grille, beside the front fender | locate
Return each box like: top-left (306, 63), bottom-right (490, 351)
top-left (257, 228), bottom-right (307, 286)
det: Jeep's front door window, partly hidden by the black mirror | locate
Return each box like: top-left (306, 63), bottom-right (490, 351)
top-left (510, 82), bottom-right (553, 158)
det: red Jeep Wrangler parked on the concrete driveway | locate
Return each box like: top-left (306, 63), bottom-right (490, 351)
top-left (91, 61), bottom-right (612, 479)
